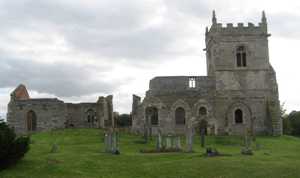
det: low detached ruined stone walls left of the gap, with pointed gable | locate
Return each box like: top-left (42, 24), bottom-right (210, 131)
top-left (7, 85), bottom-right (113, 134)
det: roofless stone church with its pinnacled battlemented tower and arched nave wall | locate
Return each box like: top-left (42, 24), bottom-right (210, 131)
top-left (132, 12), bottom-right (282, 135)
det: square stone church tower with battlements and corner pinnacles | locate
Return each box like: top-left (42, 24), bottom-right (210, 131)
top-left (205, 12), bottom-right (282, 135)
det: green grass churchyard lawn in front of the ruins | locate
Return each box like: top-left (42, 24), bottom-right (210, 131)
top-left (0, 129), bottom-right (300, 178)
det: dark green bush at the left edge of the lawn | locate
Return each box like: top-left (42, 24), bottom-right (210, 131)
top-left (0, 122), bottom-right (30, 169)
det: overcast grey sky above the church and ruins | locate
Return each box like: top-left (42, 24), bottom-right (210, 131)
top-left (0, 0), bottom-right (300, 117)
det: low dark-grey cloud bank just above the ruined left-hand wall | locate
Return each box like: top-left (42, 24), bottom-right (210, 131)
top-left (0, 56), bottom-right (122, 97)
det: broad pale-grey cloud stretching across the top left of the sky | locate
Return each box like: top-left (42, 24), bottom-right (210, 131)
top-left (0, 0), bottom-right (209, 63)
